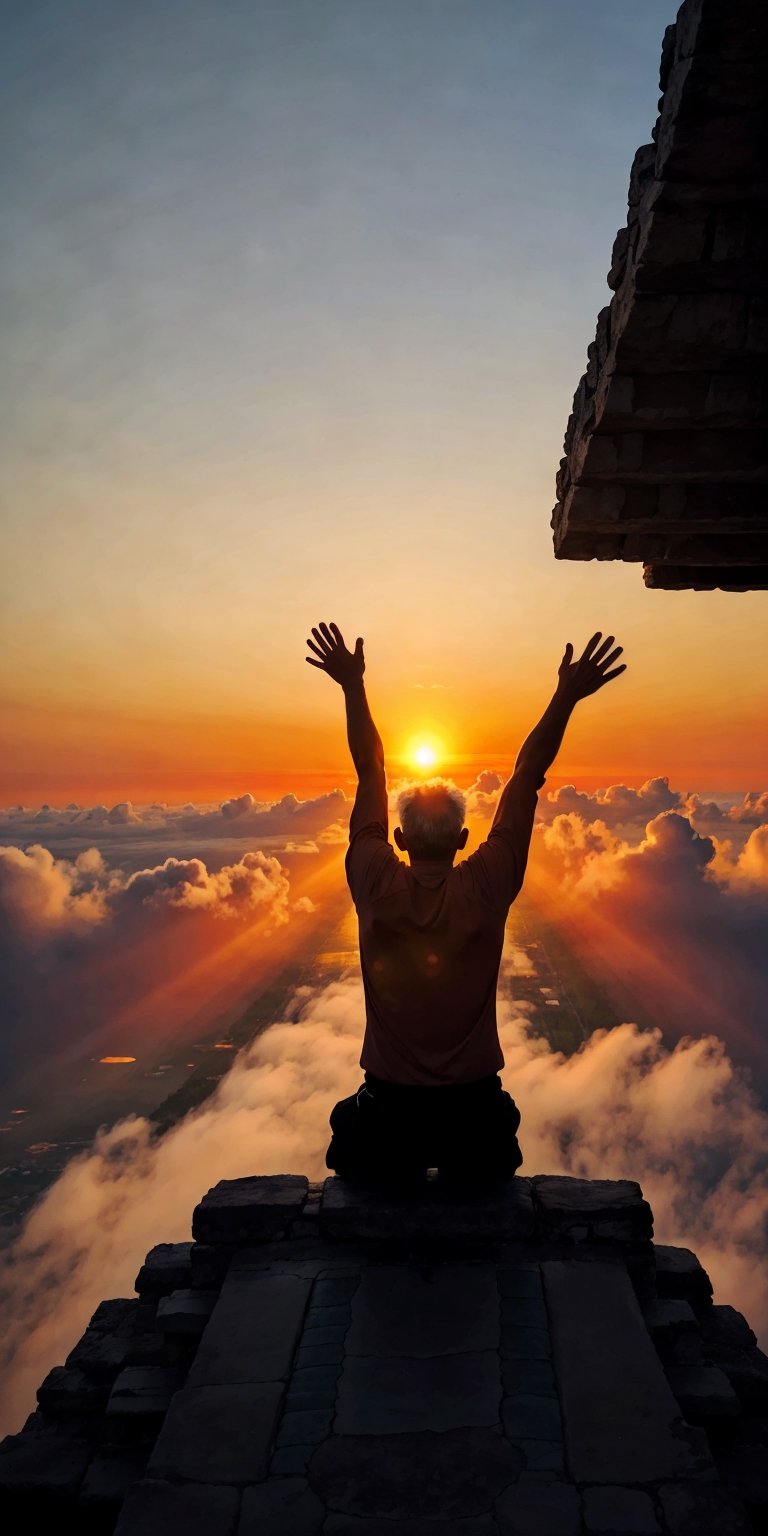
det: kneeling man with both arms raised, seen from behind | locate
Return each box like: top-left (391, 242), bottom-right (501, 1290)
top-left (307, 624), bottom-right (625, 1187)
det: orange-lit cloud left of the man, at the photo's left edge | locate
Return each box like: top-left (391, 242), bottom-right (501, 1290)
top-left (0, 843), bottom-right (293, 1081)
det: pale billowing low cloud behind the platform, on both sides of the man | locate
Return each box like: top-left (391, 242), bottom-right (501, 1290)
top-left (0, 978), bottom-right (768, 1430)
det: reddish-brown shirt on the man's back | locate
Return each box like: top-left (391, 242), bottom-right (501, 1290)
top-left (346, 773), bottom-right (544, 1086)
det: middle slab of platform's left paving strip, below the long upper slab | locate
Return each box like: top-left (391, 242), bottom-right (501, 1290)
top-left (147, 1382), bottom-right (283, 1485)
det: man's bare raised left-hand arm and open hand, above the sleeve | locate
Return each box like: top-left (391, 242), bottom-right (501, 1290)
top-left (306, 624), bottom-right (387, 836)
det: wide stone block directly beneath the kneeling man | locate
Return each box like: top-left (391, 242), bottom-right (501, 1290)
top-left (319, 1178), bottom-right (533, 1244)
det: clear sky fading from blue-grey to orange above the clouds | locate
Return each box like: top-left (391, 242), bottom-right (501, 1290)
top-left (0, 0), bottom-right (768, 799)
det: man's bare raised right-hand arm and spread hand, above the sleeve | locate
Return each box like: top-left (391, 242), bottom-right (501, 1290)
top-left (493, 630), bottom-right (627, 826)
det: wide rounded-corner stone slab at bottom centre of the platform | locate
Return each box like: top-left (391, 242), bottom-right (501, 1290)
top-left (309, 1428), bottom-right (524, 1528)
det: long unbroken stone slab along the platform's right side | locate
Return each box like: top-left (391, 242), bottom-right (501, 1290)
top-left (542, 1260), bottom-right (714, 1485)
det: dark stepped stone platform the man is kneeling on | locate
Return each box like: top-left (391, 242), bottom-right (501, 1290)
top-left (0, 1175), bottom-right (768, 1536)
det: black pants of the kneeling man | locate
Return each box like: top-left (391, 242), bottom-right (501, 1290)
top-left (326, 1072), bottom-right (522, 1189)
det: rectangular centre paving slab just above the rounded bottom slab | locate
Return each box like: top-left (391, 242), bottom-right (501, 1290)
top-left (333, 1350), bottom-right (501, 1436)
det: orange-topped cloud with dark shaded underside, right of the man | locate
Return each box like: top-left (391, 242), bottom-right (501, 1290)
top-left (528, 811), bottom-right (768, 1091)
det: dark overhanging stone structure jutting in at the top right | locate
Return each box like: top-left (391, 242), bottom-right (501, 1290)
top-left (551, 0), bottom-right (768, 591)
